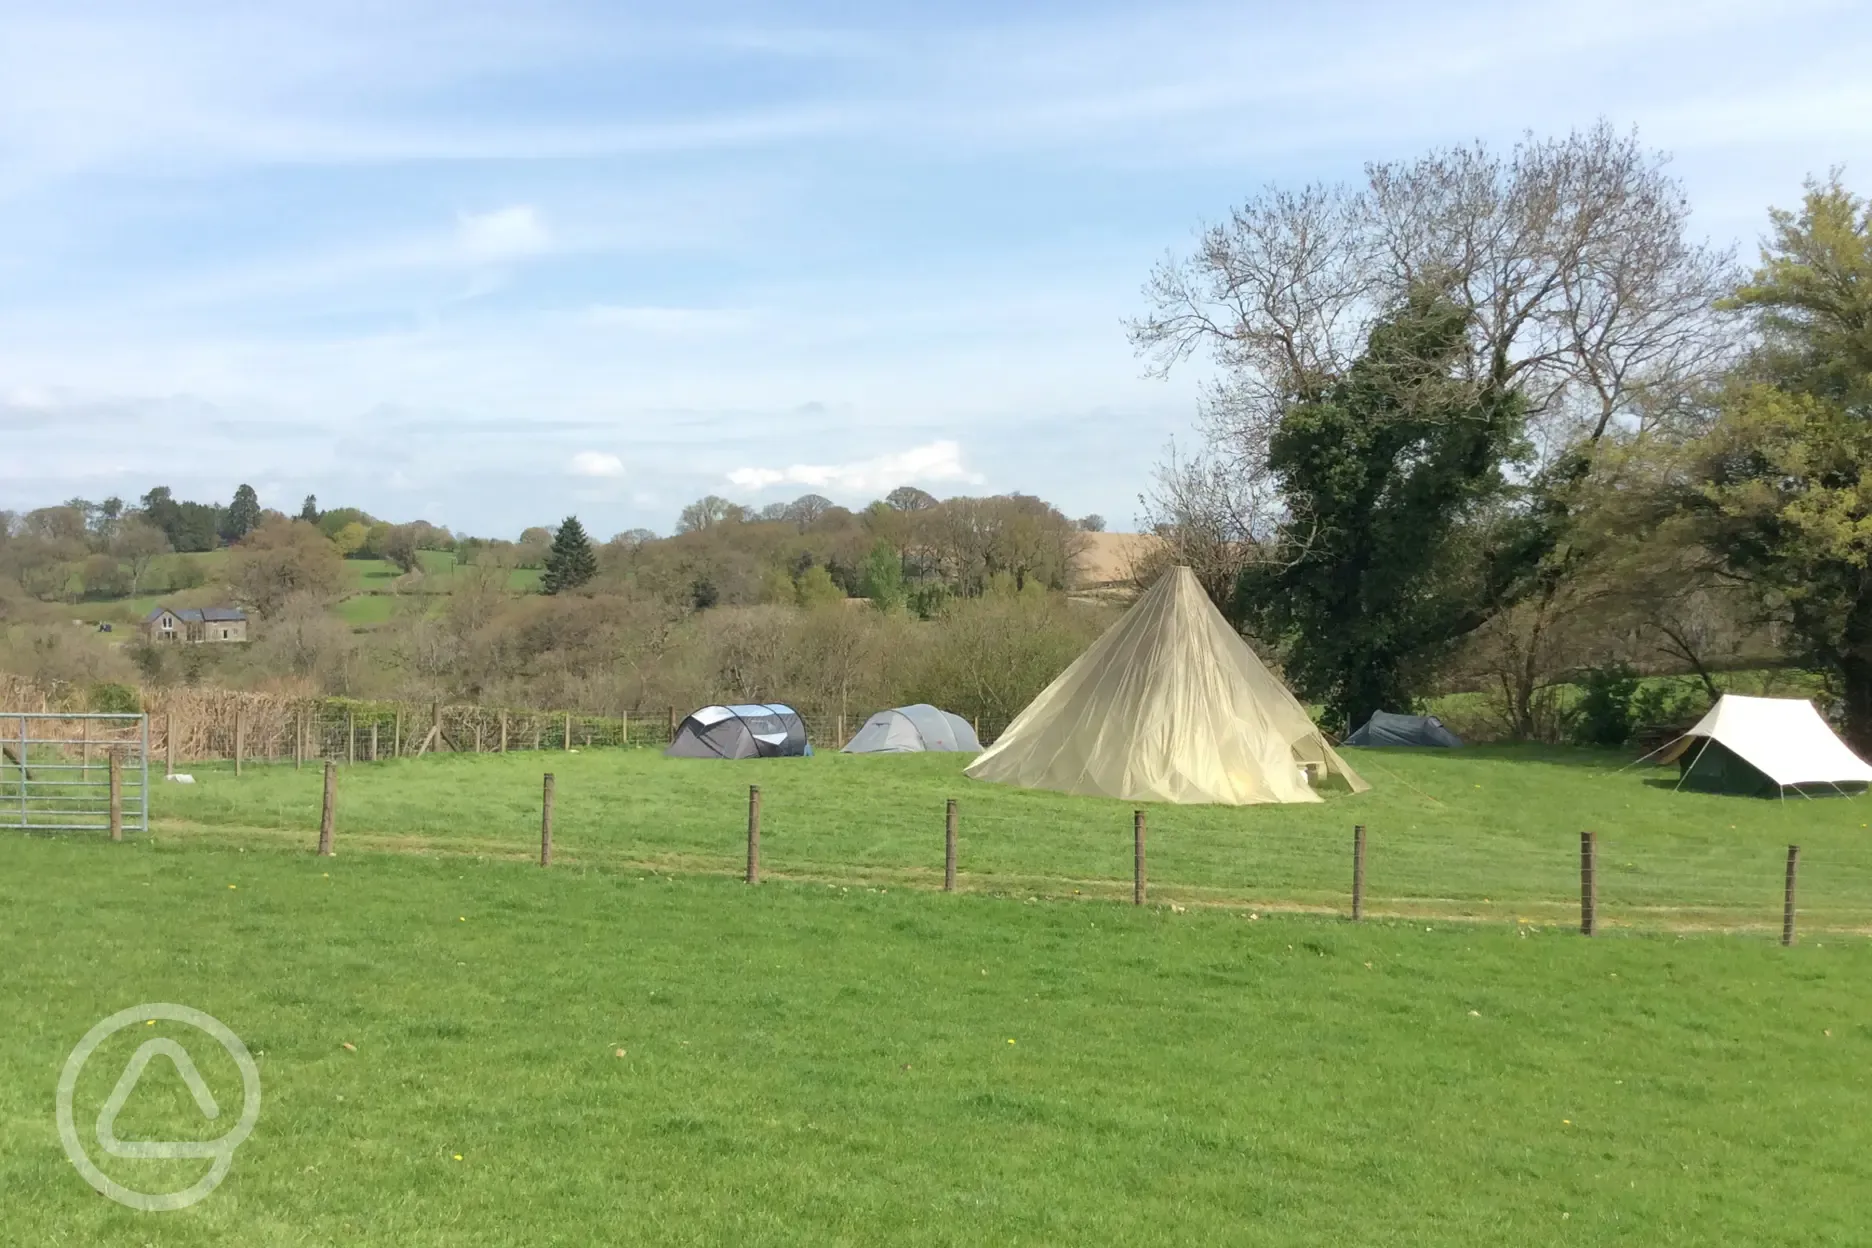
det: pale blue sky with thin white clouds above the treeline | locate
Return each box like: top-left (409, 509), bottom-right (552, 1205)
top-left (0, 0), bottom-right (1872, 537)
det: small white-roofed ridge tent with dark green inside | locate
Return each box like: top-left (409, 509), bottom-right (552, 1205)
top-left (1659, 694), bottom-right (1872, 793)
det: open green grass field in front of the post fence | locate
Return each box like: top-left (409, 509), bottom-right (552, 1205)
top-left (0, 834), bottom-right (1872, 1248)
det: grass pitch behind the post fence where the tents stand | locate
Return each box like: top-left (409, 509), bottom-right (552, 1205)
top-left (155, 747), bottom-right (1872, 930)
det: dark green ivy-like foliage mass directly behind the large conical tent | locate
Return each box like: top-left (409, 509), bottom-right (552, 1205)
top-left (1234, 290), bottom-right (1524, 726)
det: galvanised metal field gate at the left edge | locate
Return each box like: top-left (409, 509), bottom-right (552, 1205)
top-left (0, 711), bottom-right (150, 833)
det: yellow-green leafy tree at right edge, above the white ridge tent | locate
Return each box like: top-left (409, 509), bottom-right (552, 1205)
top-left (1685, 178), bottom-right (1872, 740)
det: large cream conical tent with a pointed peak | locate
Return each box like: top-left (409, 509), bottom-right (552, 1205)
top-left (968, 567), bottom-right (1370, 806)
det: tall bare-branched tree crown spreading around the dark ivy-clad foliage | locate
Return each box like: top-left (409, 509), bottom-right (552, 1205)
top-left (1131, 123), bottom-right (1733, 673)
